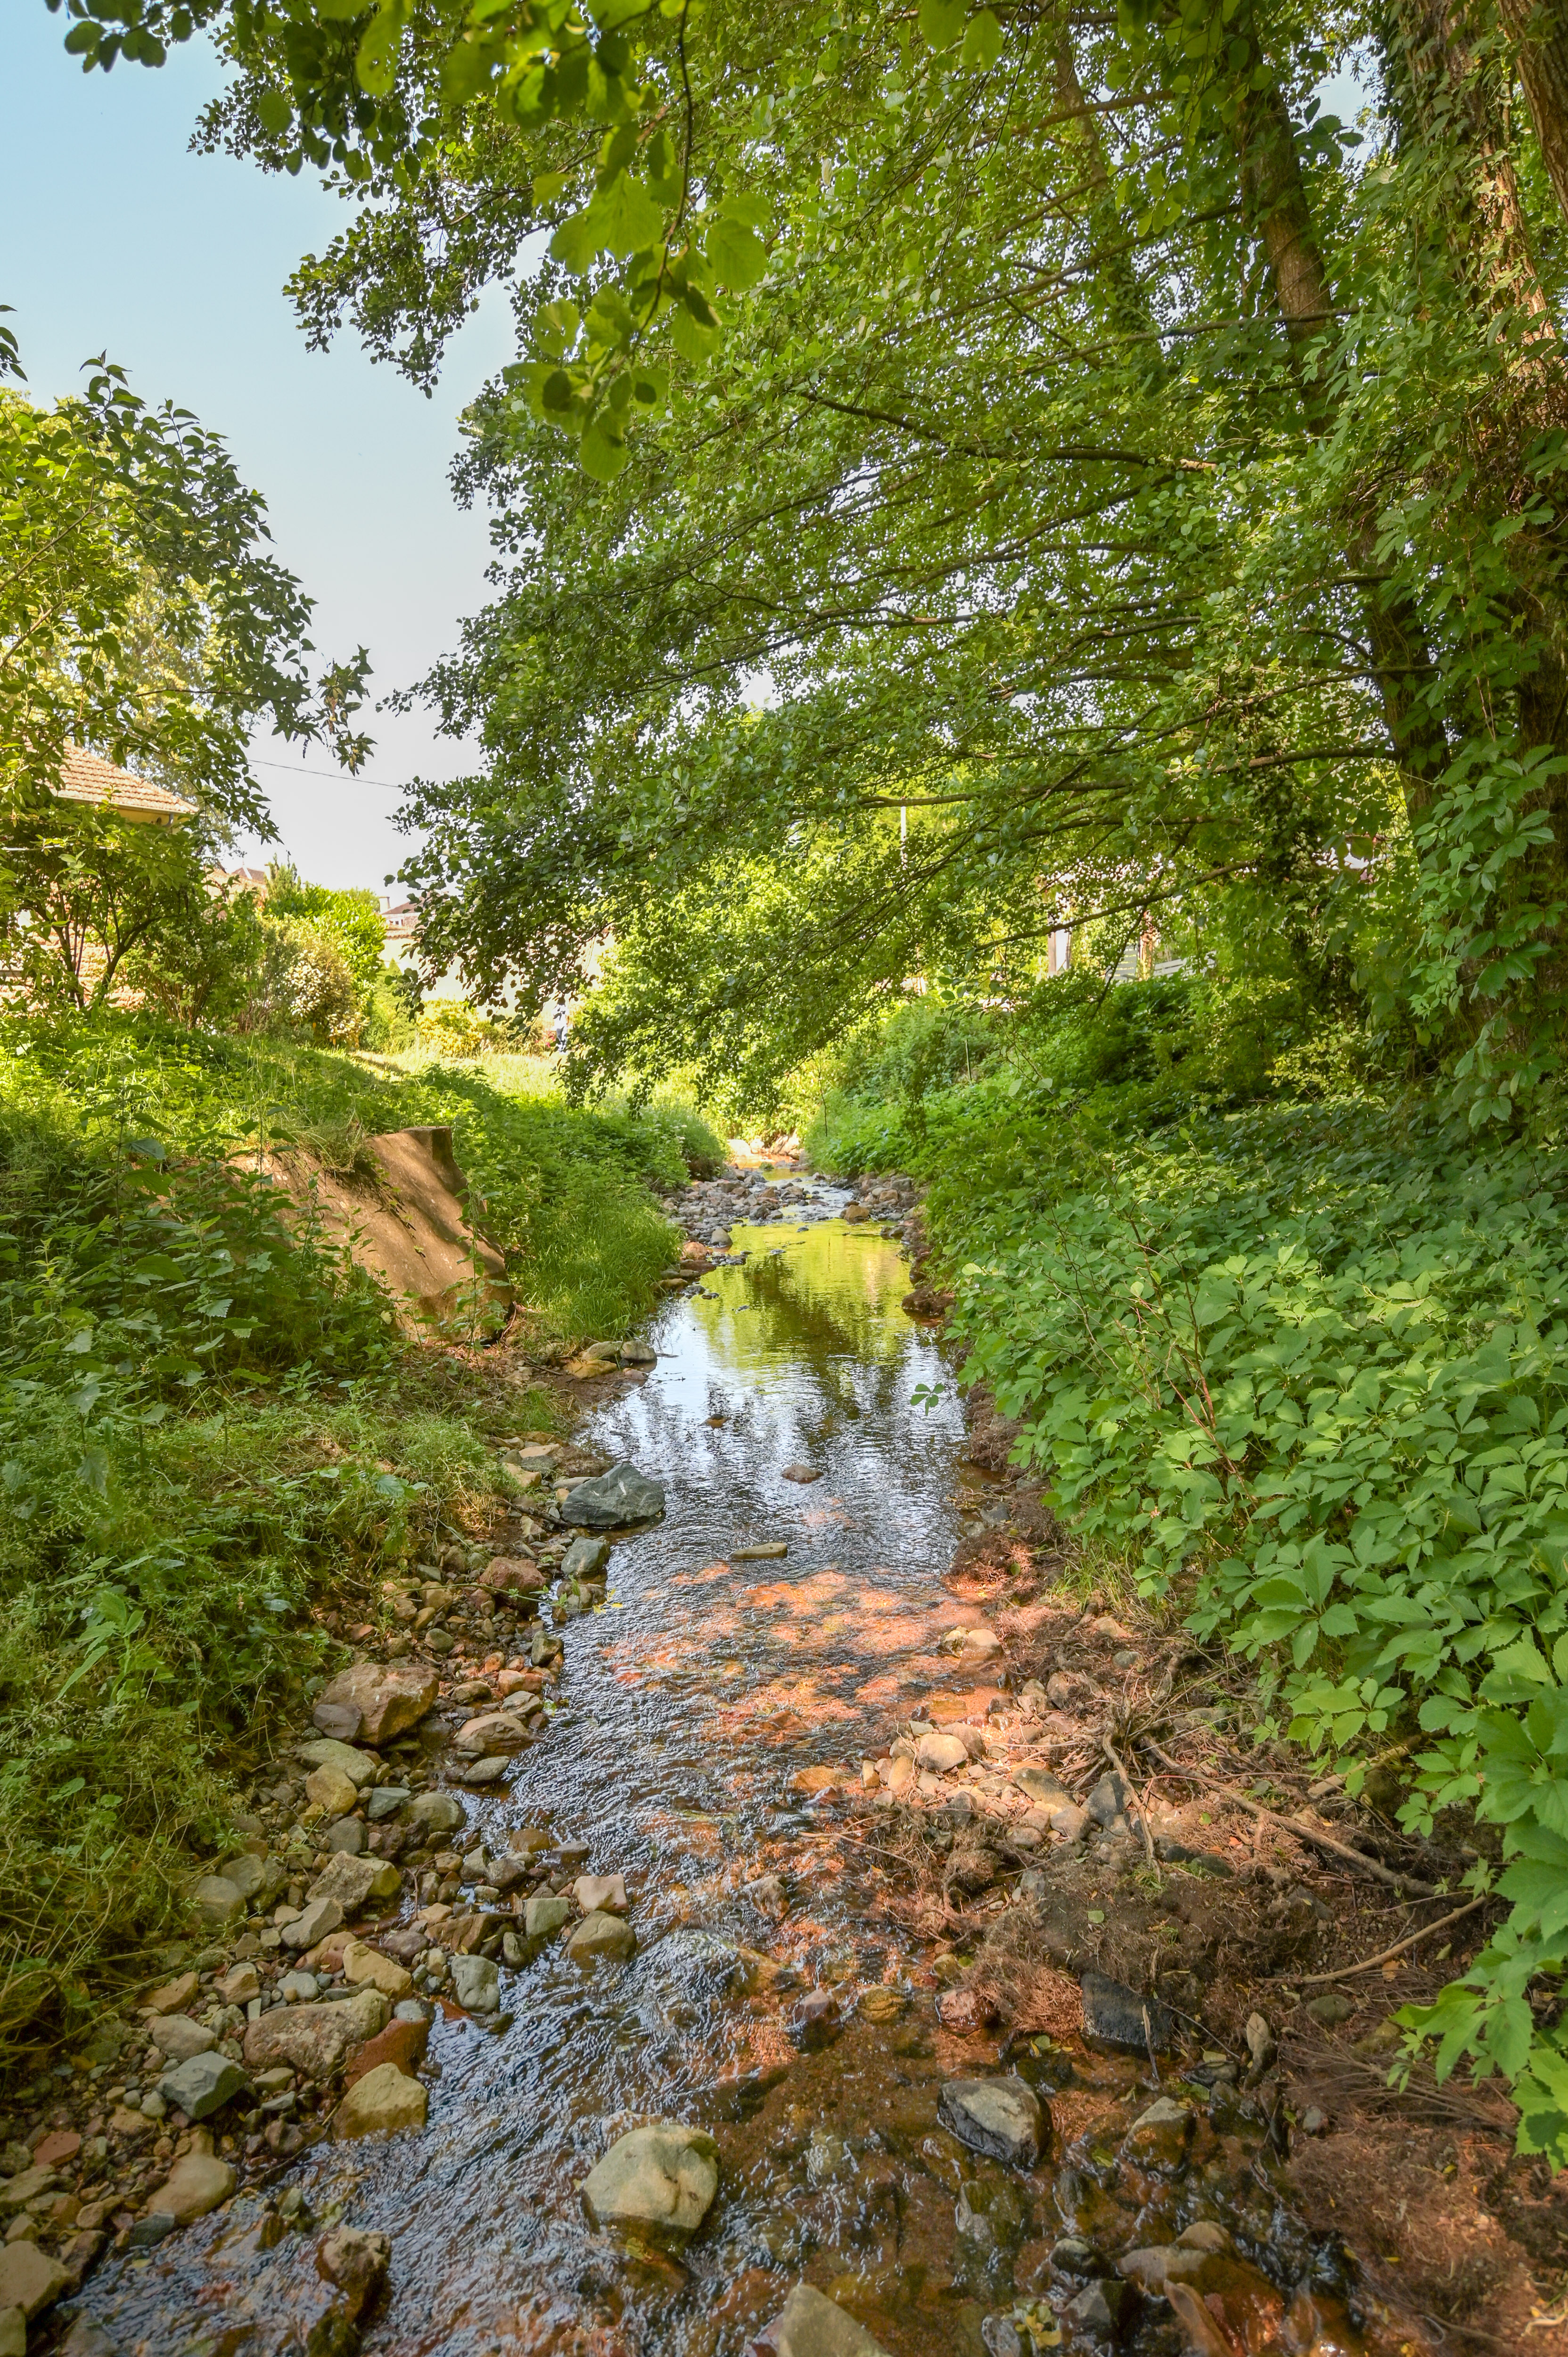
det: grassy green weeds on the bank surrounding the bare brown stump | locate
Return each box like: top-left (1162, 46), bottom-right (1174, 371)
top-left (0, 1016), bottom-right (722, 2053)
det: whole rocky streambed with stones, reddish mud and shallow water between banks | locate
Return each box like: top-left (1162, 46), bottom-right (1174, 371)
top-left (0, 1171), bottom-right (1561, 2357)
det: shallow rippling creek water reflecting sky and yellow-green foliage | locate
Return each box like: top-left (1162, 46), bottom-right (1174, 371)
top-left (82, 1197), bottom-right (1136, 2357)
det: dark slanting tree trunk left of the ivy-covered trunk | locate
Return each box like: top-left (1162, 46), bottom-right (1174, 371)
top-left (1238, 82), bottom-right (1448, 818)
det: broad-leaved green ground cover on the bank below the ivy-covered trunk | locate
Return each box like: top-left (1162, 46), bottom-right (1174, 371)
top-left (809, 983), bottom-right (1568, 2166)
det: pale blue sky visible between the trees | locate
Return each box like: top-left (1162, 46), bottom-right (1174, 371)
top-left (0, 0), bottom-right (512, 891)
